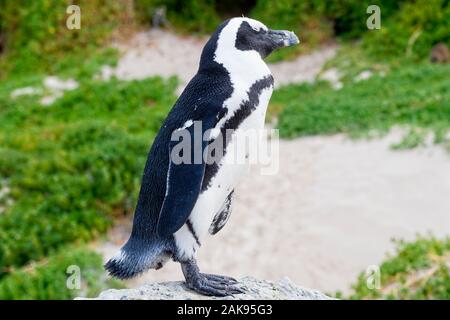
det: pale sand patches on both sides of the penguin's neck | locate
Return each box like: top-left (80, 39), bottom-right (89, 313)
top-left (109, 30), bottom-right (336, 93)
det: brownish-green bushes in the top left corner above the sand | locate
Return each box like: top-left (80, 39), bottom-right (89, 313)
top-left (0, 0), bottom-right (127, 78)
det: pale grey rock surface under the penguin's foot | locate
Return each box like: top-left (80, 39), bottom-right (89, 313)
top-left (81, 277), bottom-right (332, 300)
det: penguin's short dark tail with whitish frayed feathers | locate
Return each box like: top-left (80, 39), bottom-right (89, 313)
top-left (104, 238), bottom-right (172, 279)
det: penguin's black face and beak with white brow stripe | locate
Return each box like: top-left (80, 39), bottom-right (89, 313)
top-left (231, 17), bottom-right (300, 59)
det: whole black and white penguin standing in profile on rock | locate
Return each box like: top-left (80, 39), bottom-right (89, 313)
top-left (105, 18), bottom-right (299, 295)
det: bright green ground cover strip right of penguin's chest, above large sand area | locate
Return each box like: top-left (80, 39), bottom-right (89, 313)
top-left (273, 64), bottom-right (450, 142)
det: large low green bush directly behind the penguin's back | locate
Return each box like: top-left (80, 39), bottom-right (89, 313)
top-left (0, 78), bottom-right (177, 277)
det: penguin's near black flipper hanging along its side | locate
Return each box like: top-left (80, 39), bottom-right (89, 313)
top-left (157, 112), bottom-right (218, 238)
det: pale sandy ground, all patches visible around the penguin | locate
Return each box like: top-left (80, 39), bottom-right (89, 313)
top-left (95, 31), bottom-right (450, 291)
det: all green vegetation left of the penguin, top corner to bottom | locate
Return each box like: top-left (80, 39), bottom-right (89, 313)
top-left (0, 0), bottom-right (177, 299)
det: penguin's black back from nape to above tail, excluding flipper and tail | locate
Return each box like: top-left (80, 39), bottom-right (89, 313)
top-left (132, 20), bottom-right (233, 238)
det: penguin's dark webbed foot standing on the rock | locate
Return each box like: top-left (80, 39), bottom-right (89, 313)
top-left (181, 260), bottom-right (245, 297)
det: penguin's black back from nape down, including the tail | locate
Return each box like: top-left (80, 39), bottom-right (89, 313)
top-left (105, 20), bottom-right (233, 279)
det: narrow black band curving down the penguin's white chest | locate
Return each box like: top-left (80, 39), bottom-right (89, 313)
top-left (201, 75), bottom-right (273, 192)
